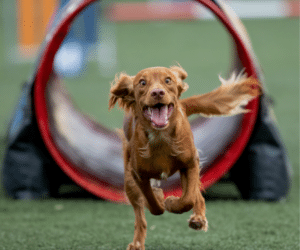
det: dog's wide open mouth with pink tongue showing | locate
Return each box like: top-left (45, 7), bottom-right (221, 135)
top-left (143, 103), bottom-right (174, 129)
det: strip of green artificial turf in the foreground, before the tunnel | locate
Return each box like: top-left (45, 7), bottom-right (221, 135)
top-left (0, 197), bottom-right (299, 250)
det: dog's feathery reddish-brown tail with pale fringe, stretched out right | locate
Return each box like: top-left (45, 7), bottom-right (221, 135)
top-left (181, 73), bottom-right (262, 117)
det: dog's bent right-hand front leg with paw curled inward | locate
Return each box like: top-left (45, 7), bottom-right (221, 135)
top-left (165, 165), bottom-right (200, 214)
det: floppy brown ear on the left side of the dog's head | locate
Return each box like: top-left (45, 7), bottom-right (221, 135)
top-left (108, 73), bottom-right (135, 110)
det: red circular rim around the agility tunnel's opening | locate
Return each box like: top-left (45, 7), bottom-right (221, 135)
top-left (33, 0), bottom-right (259, 202)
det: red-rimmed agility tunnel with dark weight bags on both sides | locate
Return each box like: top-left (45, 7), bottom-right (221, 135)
top-left (3, 0), bottom-right (290, 202)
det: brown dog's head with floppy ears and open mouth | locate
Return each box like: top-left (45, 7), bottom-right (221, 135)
top-left (109, 66), bottom-right (188, 129)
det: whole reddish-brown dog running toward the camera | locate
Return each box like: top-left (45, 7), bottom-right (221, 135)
top-left (109, 66), bottom-right (260, 250)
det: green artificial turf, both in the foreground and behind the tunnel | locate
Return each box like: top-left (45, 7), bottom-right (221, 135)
top-left (0, 0), bottom-right (299, 250)
